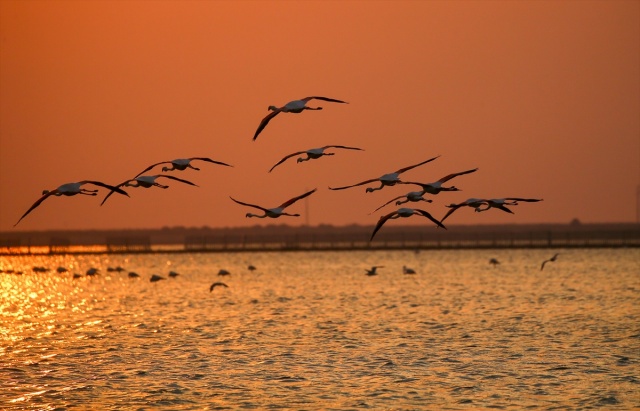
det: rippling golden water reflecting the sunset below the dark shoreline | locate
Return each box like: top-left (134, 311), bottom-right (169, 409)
top-left (0, 249), bottom-right (640, 410)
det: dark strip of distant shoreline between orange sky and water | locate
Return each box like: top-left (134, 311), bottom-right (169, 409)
top-left (0, 222), bottom-right (640, 255)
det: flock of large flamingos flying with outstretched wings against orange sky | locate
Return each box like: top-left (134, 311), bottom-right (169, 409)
top-left (14, 96), bottom-right (542, 241)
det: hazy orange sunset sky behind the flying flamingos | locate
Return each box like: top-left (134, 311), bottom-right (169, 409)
top-left (0, 0), bottom-right (640, 231)
